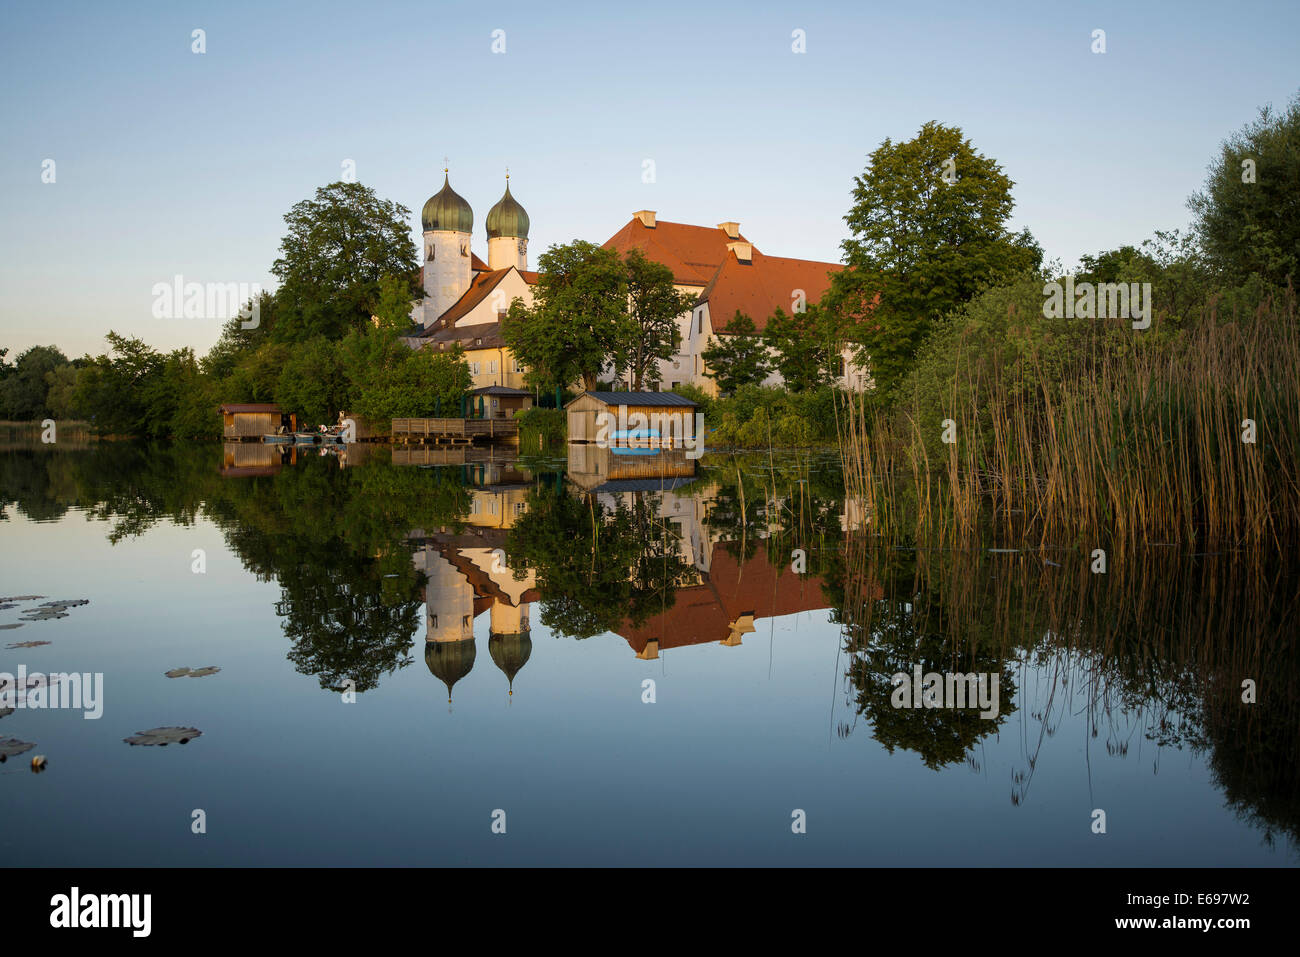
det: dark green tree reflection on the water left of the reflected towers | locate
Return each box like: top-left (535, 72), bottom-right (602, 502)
top-left (0, 442), bottom-right (469, 690)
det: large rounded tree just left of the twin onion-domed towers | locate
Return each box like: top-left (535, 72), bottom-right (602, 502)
top-left (270, 182), bottom-right (420, 342)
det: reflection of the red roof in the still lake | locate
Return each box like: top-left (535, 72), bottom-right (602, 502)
top-left (619, 544), bottom-right (828, 654)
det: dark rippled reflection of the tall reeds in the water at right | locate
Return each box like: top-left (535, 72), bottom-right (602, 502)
top-left (841, 536), bottom-right (1300, 844)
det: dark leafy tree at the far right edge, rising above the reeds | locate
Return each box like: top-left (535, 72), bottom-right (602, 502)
top-left (1187, 95), bottom-right (1300, 286)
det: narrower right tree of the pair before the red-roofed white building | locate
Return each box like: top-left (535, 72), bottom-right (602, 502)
top-left (616, 250), bottom-right (696, 390)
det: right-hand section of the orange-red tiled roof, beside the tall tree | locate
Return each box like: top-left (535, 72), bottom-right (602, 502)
top-left (699, 248), bottom-right (844, 334)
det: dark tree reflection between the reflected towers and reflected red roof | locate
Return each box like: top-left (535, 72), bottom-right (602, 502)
top-left (506, 488), bottom-right (693, 638)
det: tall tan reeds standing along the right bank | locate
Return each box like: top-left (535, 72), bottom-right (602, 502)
top-left (839, 291), bottom-right (1300, 550)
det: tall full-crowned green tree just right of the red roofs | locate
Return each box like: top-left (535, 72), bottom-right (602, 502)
top-left (823, 122), bottom-right (1043, 387)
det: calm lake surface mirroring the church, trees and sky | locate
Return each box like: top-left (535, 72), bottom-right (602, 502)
top-left (0, 443), bottom-right (1300, 866)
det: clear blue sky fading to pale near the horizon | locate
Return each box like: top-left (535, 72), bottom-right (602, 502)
top-left (0, 0), bottom-right (1300, 360)
